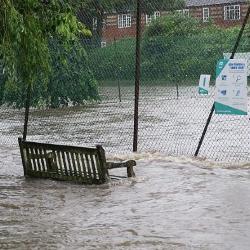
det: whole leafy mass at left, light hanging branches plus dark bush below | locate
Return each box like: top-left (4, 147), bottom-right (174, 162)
top-left (0, 0), bottom-right (97, 107)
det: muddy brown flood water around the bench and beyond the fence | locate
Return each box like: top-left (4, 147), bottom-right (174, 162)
top-left (0, 85), bottom-right (250, 250)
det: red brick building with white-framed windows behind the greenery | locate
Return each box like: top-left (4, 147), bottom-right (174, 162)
top-left (96, 0), bottom-right (249, 46)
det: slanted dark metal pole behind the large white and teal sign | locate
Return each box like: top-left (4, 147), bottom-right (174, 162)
top-left (194, 6), bottom-right (250, 156)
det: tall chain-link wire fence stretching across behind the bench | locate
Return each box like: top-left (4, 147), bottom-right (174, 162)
top-left (0, 1), bottom-right (250, 164)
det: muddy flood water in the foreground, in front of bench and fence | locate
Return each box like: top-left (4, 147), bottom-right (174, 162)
top-left (0, 151), bottom-right (250, 250)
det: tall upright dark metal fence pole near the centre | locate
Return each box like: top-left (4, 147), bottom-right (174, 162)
top-left (133, 0), bottom-right (142, 152)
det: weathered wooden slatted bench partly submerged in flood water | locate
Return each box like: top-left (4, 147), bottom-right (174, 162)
top-left (18, 138), bottom-right (136, 184)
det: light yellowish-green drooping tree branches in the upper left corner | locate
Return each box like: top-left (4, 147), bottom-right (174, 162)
top-left (0, 0), bottom-right (87, 84)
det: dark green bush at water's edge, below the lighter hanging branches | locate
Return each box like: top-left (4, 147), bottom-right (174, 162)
top-left (0, 39), bottom-right (99, 108)
